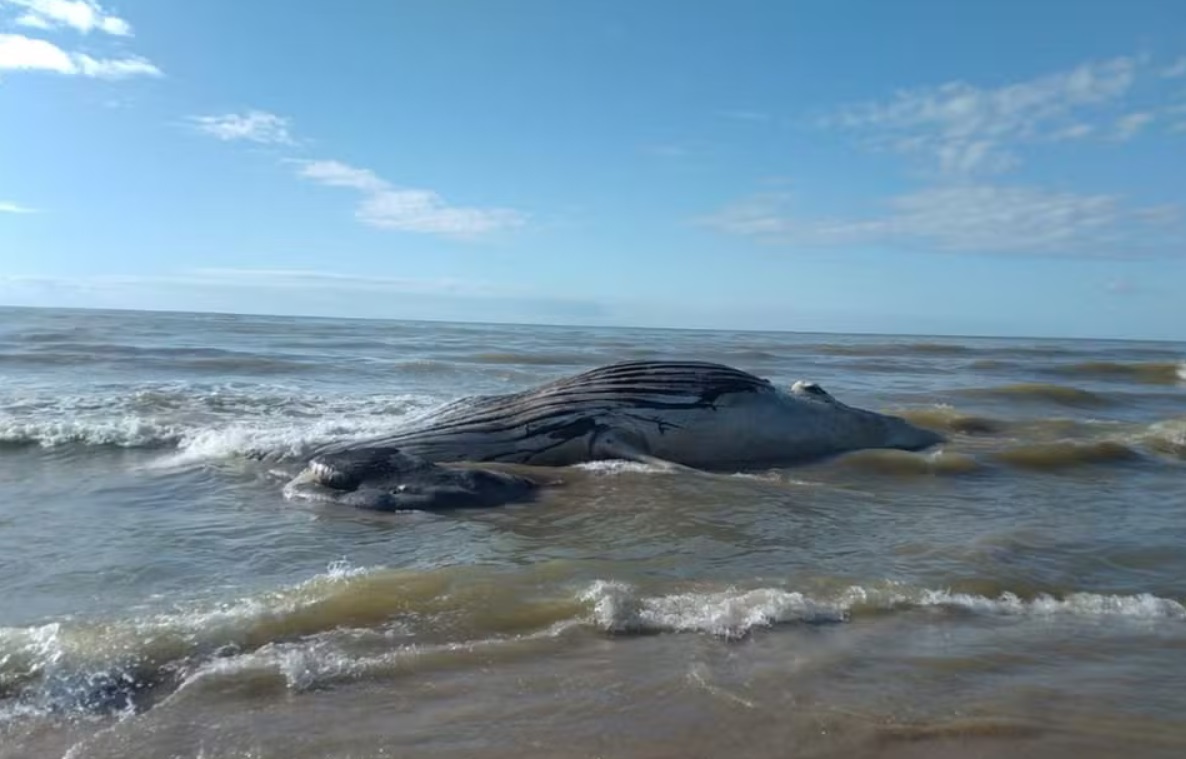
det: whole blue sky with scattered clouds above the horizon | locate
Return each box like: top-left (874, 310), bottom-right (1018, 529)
top-left (0, 0), bottom-right (1186, 339)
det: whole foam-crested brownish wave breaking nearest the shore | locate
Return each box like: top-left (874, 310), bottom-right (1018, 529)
top-left (0, 563), bottom-right (1186, 722)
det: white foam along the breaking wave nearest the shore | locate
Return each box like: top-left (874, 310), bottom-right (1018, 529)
top-left (0, 561), bottom-right (1186, 722)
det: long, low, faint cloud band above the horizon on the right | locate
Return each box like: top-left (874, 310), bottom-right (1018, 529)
top-left (703, 185), bottom-right (1186, 256)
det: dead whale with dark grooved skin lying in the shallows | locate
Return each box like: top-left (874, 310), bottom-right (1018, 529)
top-left (288, 361), bottom-right (945, 510)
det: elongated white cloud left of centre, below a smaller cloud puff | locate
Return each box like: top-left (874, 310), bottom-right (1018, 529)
top-left (298, 161), bottom-right (527, 238)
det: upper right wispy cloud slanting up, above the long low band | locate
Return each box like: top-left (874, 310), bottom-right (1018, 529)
top-left (820, 57), bottom-right (1137, 176)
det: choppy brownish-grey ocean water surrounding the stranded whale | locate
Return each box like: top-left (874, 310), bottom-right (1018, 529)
top-left (0, 308), bottom-right (1186, 759)
